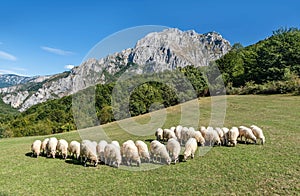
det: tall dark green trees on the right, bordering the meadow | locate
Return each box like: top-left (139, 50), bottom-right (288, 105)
top-left (216, 28), bottom-right (300, 94)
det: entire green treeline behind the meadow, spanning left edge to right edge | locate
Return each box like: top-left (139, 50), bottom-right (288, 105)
top-left (0, 28), bottom-right (300, 137)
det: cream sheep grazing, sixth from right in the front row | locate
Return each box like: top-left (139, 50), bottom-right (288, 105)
top-left (104, 144), bottom-right (122, 168)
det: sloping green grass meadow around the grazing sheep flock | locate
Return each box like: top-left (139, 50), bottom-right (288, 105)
top-left (0, 95), bottom-right (300, 195)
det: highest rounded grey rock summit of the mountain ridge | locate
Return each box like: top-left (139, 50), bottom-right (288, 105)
top-left (131, 29), bottom-right (231, 71)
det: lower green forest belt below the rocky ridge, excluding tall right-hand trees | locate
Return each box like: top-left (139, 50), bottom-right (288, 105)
top-left (0, 66), bottom-right (209, 137)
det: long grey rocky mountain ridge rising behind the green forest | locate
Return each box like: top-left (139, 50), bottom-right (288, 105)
top-left (0, 29), bottom-right (231, 111)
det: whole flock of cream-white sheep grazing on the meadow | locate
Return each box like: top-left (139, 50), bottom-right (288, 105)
top-left (31, 125), bottom-right (265, 167)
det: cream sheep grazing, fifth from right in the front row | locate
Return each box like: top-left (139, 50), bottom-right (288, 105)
top-left (122, 140), bottom-right (141, 166)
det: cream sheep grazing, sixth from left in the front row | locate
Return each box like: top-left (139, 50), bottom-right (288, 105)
top-left (80, 140), bottom-right (98, 167)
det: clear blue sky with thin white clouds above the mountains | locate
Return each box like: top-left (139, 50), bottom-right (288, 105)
top-left (0, 0), bottom-right (300, 76)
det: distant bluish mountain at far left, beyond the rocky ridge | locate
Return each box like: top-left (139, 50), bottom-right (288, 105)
top-left (0, 74), bottom-right (36, 88)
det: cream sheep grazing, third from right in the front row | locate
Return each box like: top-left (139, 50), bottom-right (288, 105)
top-left (150, 140), bottom-right (171, 165)
